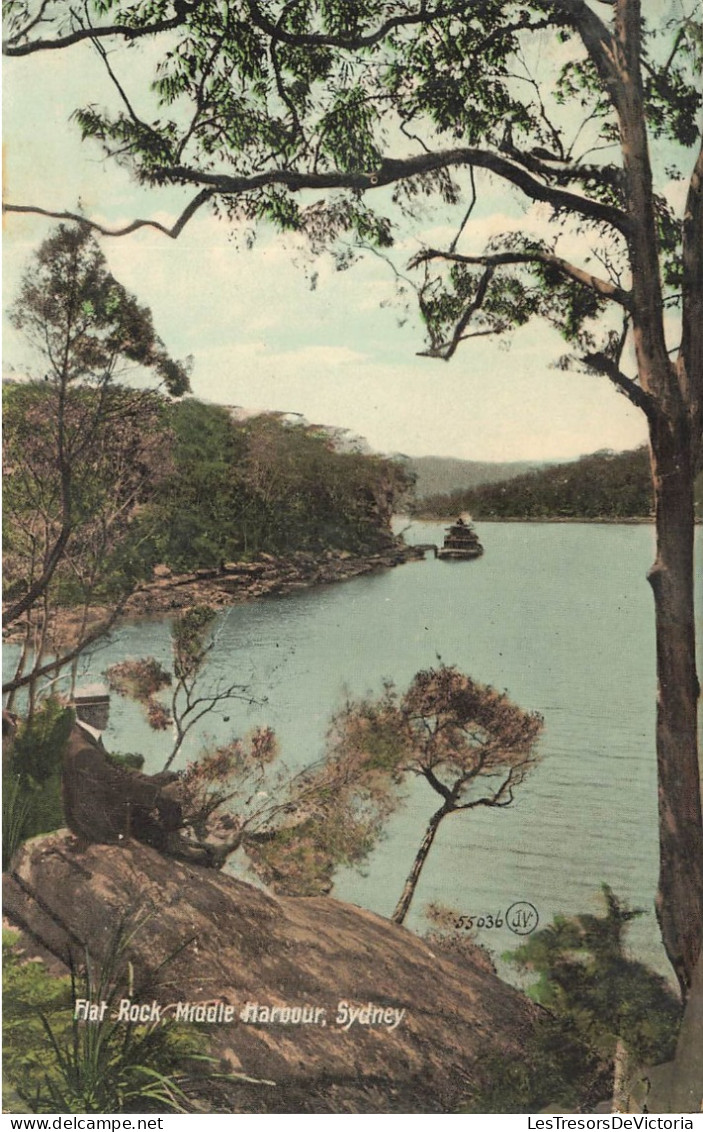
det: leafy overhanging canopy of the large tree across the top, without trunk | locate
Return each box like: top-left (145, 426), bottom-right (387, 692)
top-left (5, 0), bottom-right (702, 389)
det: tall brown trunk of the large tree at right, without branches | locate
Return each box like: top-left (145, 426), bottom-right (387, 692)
top-left (610, 0), bottom-right (703, 997)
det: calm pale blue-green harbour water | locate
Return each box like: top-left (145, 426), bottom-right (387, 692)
top-left (8, 523), bottom-right (697, 971)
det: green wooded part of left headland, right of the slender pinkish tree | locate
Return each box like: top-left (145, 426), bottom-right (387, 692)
top-left (149, 400), bottom-right (408, 569)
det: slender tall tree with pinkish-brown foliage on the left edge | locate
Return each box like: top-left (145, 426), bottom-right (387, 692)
top-left (3, 225), bottom-right (188, 700)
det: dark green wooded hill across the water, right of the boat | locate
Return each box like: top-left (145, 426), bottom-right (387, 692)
top-left (415, 448), bottom-right (653, 520)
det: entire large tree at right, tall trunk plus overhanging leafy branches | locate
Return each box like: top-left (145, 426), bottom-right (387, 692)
top-left (5, 0), bottom-right (703, 994)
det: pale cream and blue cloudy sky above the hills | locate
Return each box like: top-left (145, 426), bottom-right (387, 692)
top-left (3, 11), bottom-right (674, 461)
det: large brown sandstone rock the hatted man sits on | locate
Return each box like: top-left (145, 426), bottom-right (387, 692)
top-left (5, 831), bottom-right (534, 1113)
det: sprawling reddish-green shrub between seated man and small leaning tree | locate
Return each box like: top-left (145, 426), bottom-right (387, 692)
top-left (106, 606), bottom-right (392, 878)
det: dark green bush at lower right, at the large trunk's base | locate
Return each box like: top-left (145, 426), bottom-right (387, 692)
top-left (465, 885), bottom-right (681, 1113)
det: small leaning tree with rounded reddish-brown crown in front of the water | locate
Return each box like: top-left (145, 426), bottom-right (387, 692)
top-left (323, 664), bottom-right (542, 924)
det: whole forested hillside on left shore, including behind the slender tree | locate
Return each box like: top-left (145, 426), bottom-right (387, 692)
top-left (3, 383), bottom-right (409, 604)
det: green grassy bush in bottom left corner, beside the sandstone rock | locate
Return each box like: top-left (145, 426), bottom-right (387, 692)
top-left (2, 925), bottom-right (212, 1114)
